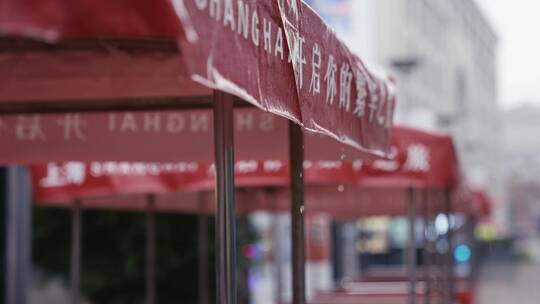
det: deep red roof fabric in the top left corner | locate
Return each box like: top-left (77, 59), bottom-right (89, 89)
top-left (0, 0), bottom-right (183, 41)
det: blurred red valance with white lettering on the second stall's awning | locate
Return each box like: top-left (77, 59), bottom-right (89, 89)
top-left (28, 128), bottom-right (459, 201)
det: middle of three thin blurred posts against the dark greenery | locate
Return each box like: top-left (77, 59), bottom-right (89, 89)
top-left (146, 194), bottom-right (156, 304)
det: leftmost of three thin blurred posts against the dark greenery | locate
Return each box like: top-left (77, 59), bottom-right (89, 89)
top-left (70, 200), bottom-right (82, 304)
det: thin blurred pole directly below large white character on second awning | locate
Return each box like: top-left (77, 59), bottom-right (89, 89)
top-left (407, 188), bottom-right (416, 304)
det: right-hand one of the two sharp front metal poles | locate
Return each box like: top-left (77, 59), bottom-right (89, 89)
top-left (289, 122), bottom-right (306, 304)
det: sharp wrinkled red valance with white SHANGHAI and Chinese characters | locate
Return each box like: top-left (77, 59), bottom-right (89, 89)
top-left (174, 0), bottom-right (395, 155)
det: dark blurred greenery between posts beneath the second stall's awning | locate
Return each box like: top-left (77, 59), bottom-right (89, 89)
top-left (33, 208), bottom-right (258, 304)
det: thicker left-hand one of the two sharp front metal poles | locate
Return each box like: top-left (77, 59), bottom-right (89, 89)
top-left (214, 91), bottom-right (236, 304)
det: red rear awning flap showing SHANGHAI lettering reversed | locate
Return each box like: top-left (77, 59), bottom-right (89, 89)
top-left (0, 109), bottom-right (372, 164)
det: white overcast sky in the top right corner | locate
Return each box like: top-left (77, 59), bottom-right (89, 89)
top-left (476, 0), bottom-right (540, 108)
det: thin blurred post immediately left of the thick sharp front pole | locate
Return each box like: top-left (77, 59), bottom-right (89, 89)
top-left (197, 193), bottom-right (210, 304)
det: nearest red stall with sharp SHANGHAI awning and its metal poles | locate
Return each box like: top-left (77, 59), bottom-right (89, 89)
top-left (0, 0), bottom-right (395, 304)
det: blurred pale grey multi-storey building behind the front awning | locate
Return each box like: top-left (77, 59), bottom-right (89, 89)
top-left (310, 0), bottom-right (507, 233)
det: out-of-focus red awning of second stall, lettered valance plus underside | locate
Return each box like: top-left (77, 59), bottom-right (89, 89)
top-left (32, 128), bottom-right (467, 218)
